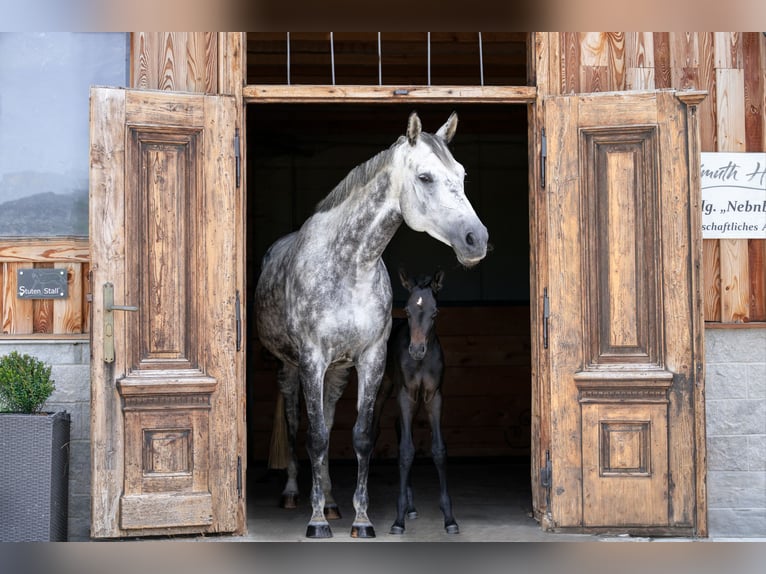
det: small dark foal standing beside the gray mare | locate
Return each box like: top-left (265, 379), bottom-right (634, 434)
top-left (373, 269), bottom-right (460, 534)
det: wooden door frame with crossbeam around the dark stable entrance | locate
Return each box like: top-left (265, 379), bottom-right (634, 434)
top-left (236, 33), bottom-right (544, 526)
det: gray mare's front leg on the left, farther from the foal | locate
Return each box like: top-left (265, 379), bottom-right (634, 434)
top-left (300, 358), bottom-right (332, 538)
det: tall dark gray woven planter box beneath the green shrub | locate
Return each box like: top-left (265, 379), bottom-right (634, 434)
top-left (0, 412), bottom-right (70, 542)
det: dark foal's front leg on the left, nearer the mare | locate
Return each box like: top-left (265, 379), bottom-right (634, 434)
top-left (390, 385), bottom-right (418, 534)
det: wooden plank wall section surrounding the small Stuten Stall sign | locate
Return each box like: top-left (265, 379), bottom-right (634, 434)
top-left (0, 238), bottom-right (90, 338)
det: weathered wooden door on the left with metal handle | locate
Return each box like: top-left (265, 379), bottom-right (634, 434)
top-left (90, 88), bottom-right (244, 538)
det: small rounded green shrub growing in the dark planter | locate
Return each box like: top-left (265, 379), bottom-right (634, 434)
top-left (0, 351), bottom-right (56, 413)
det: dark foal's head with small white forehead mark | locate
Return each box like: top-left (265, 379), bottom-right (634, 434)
top-left (399, 269), bottom-right (444, 361)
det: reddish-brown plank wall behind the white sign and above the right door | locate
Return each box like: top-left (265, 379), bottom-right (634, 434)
top-left (560, 32), bottom-right (766, 324)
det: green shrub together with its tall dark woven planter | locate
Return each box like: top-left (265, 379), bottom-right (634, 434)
top-left (0, 351), bottom-right (70, 542)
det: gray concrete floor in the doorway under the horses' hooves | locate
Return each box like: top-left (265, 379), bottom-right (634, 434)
top-left (236, 459), bottom-right (600, 543)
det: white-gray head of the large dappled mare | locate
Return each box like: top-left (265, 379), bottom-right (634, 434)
top-left (400, 112), bottom-right (489, 267)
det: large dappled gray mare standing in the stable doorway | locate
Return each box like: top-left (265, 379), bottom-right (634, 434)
top-left (255, 113), bottom-right (488, 538)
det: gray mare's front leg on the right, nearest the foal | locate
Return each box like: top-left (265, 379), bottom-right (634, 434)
top-left (351, 346), bottom-right (386, 538)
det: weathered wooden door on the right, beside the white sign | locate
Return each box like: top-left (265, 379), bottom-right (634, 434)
top-left (544, 91), bottom-right (705, 534)
